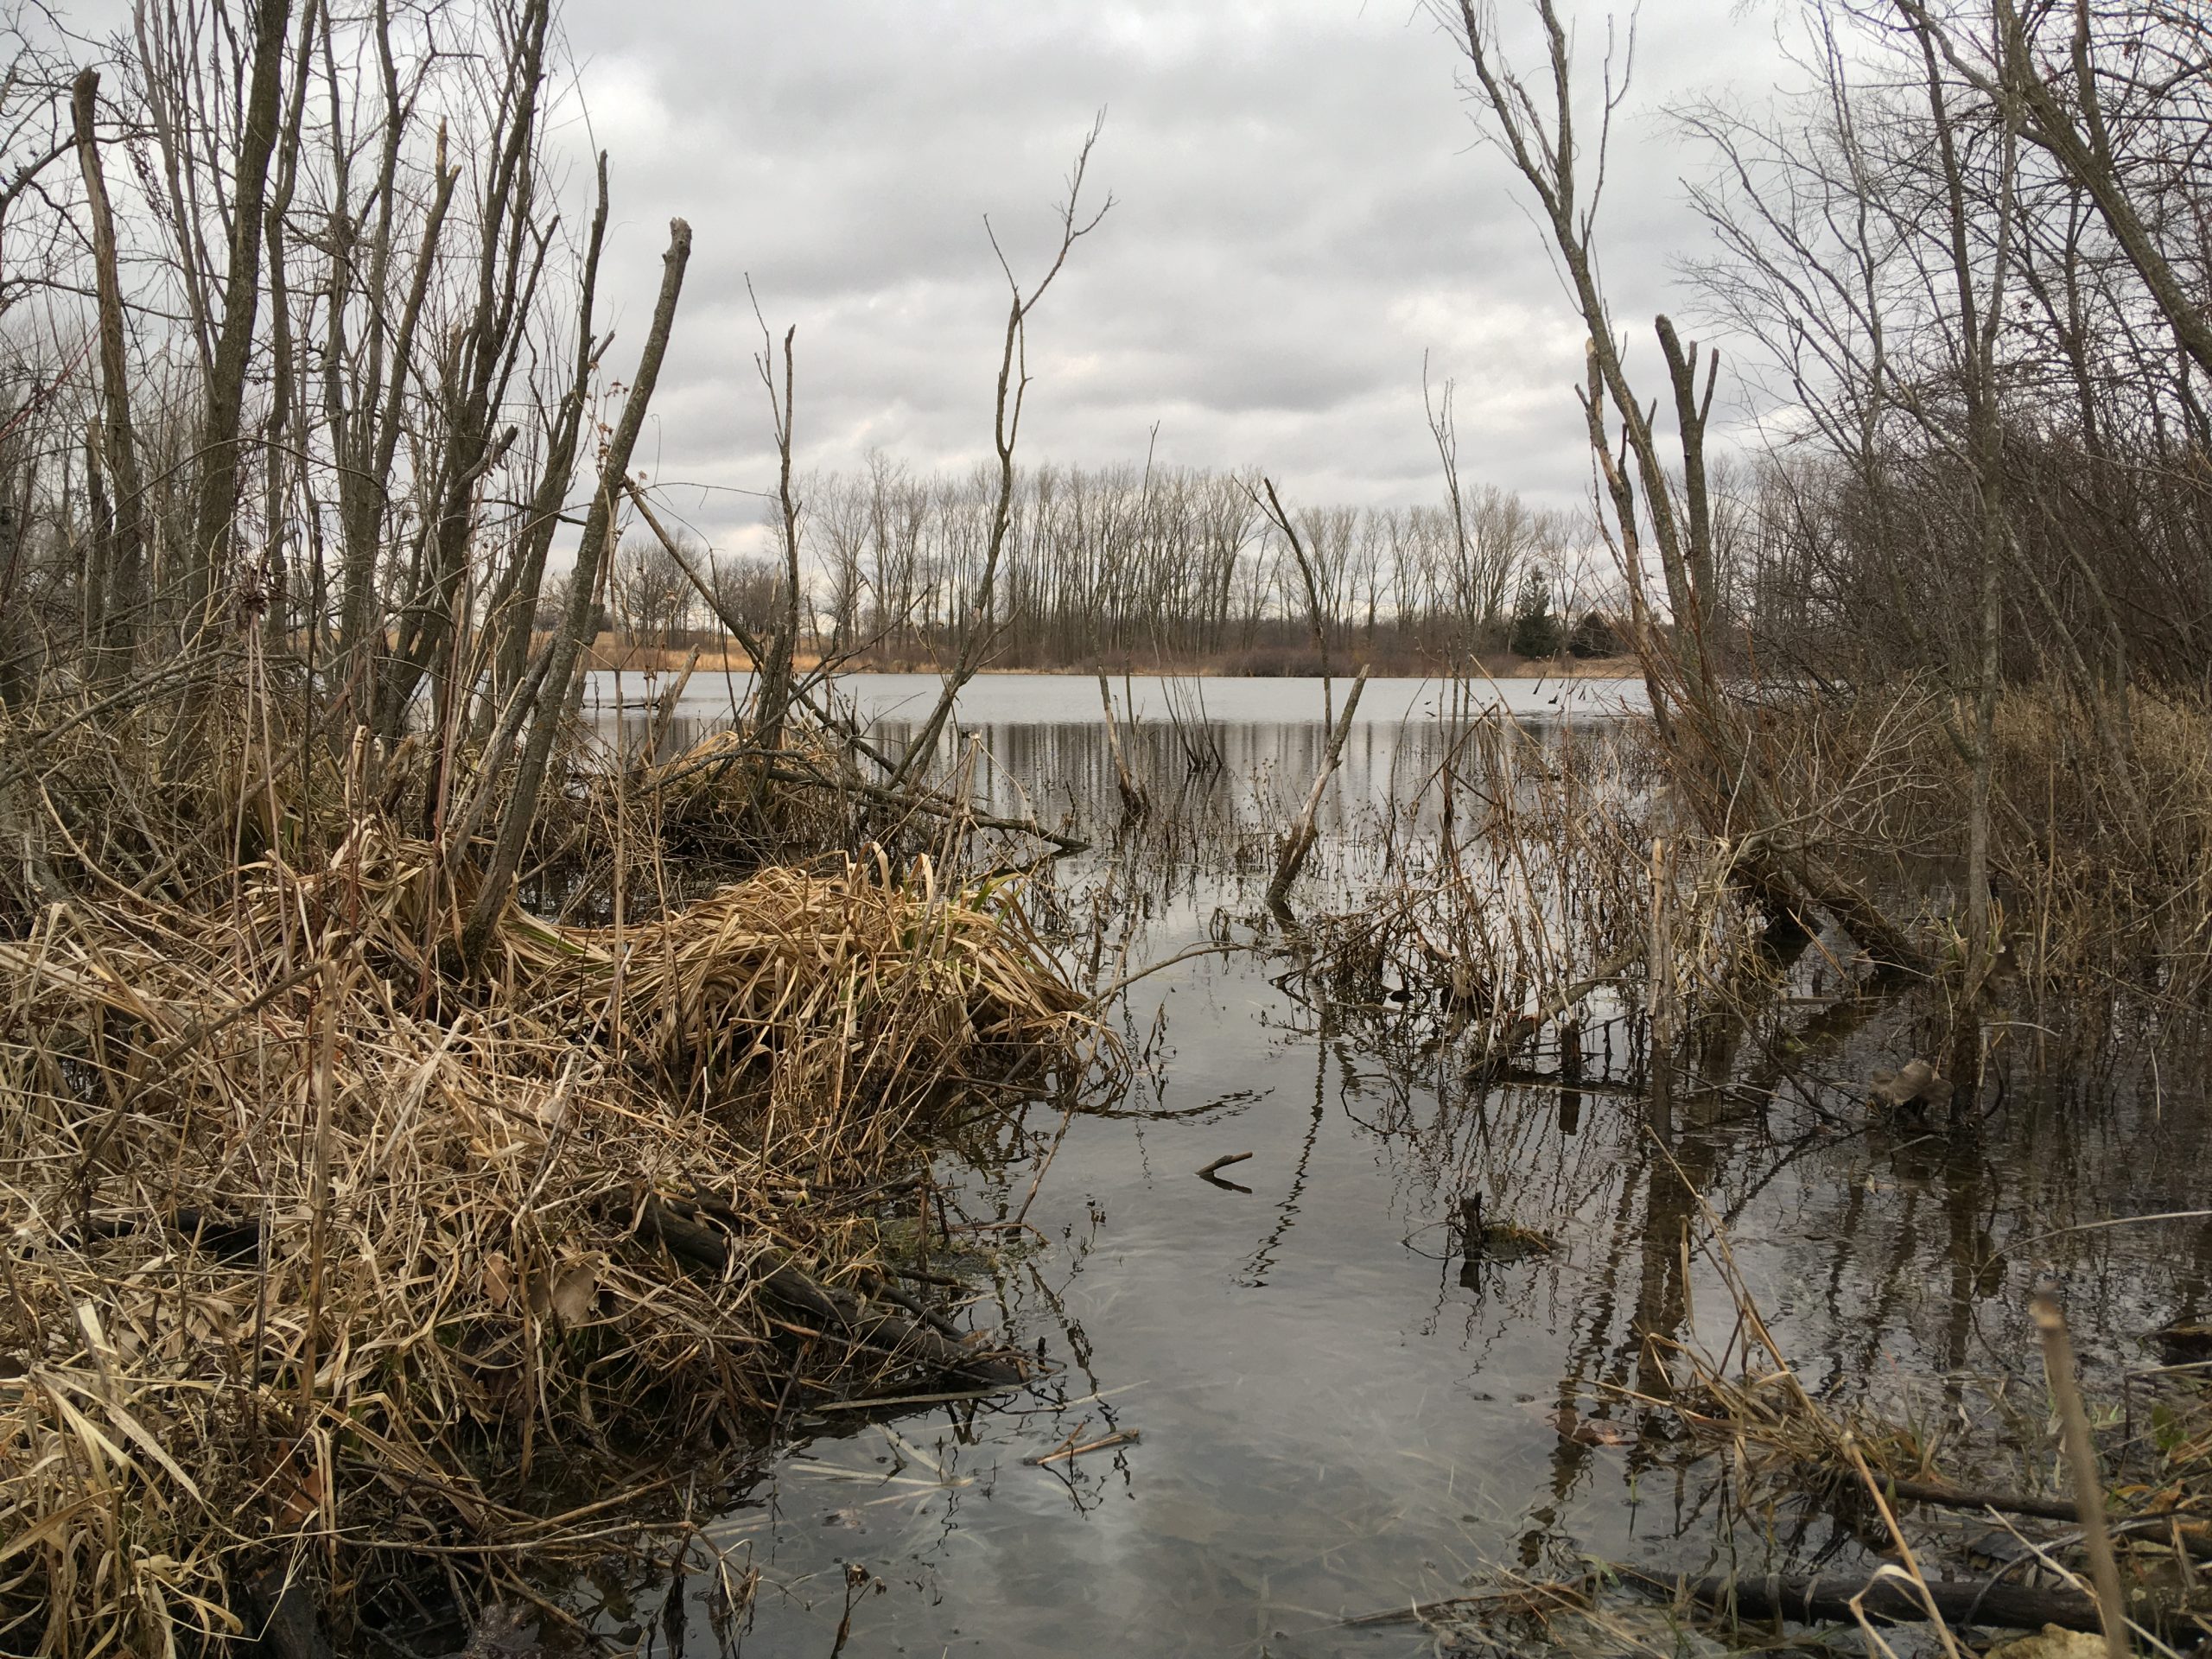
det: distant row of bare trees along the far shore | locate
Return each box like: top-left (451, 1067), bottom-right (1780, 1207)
top-left (579, 454), bottom-right (1619, 672)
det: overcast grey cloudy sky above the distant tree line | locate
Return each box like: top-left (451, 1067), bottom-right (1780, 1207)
top-left (548, 0), bottom-right (1783, 536)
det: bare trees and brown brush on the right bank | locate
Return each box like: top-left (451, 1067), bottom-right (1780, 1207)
top-left (1453, 0), bottom-right (2212, 1089)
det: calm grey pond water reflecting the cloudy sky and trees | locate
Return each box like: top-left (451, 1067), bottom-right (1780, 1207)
top-left (601, 677), bottom-right (2212, 1659)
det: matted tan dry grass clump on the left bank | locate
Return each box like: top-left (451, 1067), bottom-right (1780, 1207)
top-left (0, 827), bottom-right (1099, 1655)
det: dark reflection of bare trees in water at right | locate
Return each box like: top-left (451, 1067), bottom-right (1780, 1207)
top-left (1282, 902), bottom-right (2212, 1592)
